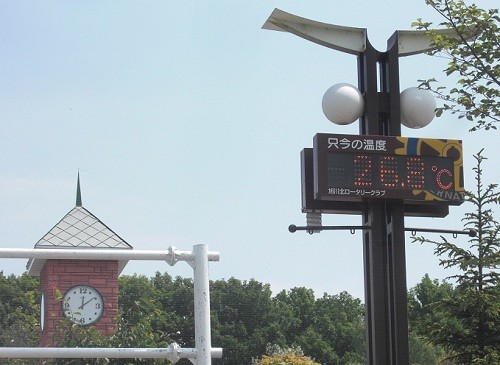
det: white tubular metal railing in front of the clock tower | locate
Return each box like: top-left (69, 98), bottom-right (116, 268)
top-left (0, 244), bottom-right (222, 365)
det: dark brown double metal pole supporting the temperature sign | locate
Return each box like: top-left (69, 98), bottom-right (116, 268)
top-left (358, 33), bottom-right (409, 365)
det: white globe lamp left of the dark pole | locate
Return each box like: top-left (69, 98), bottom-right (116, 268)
top-left (321, 83), bottom-right (365, 125)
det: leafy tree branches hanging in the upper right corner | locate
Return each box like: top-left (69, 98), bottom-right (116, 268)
top-left (413, 0), bottom-right (500, 131)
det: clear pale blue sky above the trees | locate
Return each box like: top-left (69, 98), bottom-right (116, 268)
top-left (0, 0), bottom-right (500, 298)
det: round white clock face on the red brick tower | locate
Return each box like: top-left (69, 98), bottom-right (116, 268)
top-left (62, 285), bottom-right (104, 326)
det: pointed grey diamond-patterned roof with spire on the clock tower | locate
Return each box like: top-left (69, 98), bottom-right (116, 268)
top-left (28, 172), bottom-right (132, 276)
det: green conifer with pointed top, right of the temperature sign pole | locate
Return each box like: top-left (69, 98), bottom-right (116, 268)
top-left (415, 151), bottom-right (500, 364)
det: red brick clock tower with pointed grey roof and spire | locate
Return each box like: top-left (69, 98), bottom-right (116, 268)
top-left (27, 176), bottom-right (132, 346)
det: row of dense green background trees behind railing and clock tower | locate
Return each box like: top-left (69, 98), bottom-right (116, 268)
top-left (0, 273), bottom-right (456, 365)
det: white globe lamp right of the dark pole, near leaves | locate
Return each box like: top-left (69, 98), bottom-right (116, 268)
top-left (400, 87), bottom-right (436, 129)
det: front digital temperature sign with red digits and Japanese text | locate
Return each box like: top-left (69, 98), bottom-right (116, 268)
top-left (313, 134), bottom-right (465, 205)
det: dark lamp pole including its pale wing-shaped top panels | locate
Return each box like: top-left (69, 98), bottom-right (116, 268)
top-left (263, 9), bottom-right (449, 365)
